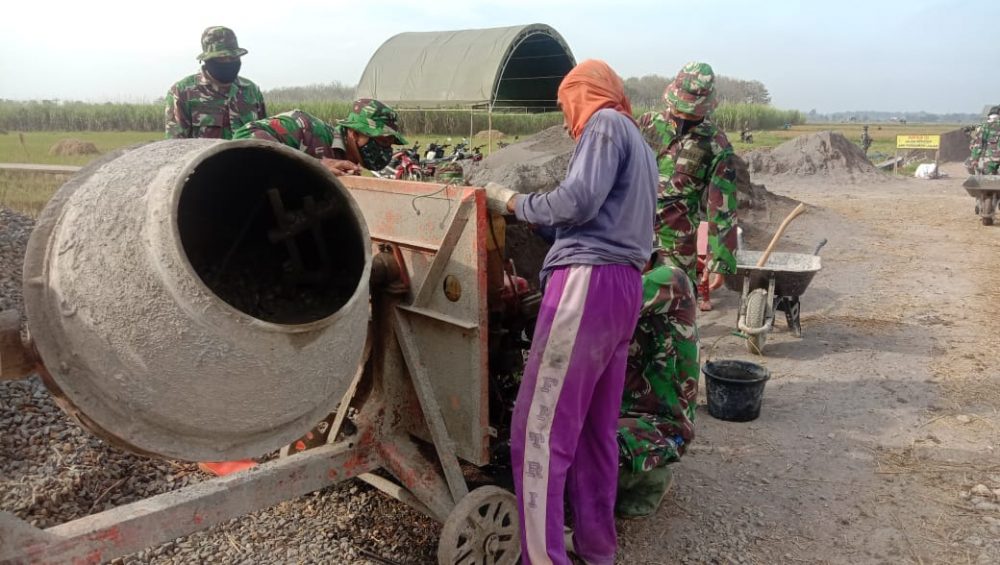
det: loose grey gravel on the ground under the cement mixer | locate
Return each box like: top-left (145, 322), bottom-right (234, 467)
top-left (0, 208), bottom-right (440, 564)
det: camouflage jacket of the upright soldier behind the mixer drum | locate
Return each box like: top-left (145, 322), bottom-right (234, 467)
top-left (165, 71), bottom-right (267, 139)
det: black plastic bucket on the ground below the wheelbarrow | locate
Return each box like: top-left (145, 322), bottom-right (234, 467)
top-left (701, 360), bottom-right (771, 422)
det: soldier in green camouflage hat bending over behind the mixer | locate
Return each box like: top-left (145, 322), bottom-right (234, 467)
top-left (233, 98), bottom-right (407, 175)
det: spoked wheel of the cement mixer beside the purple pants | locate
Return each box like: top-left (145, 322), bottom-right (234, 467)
top-left (438, 485), bottom-right (521, 565)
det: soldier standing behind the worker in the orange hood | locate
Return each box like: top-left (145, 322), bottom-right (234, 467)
top-left (639, 63), bottom-right (737, 289)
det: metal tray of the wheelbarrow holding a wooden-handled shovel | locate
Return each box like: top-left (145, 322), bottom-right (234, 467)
top-left (725, 251), bottom-right (822, 296)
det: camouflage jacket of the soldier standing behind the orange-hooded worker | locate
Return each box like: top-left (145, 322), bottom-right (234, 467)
top-left (639, 112), bottom-right (739, 284)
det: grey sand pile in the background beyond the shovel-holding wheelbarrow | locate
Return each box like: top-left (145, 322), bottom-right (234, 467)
top-left (744, 131), bottom-right (881, 182)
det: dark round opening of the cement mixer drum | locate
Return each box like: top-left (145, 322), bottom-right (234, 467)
top-left (177, 147), bottom-right (367, 324)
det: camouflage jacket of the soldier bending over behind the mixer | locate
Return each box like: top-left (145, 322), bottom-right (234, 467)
top-left (233, 109), bottom-right (346, 159)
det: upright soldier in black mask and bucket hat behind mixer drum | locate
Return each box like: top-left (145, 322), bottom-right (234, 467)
top-left (165, 26), bottom-right (267, 139)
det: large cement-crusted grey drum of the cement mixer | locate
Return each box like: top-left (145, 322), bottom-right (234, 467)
top-left (24, 140), bottom-right (371, 461)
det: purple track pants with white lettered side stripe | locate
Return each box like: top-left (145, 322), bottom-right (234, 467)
top-left (511, 265), bottom-right (642, 565)
